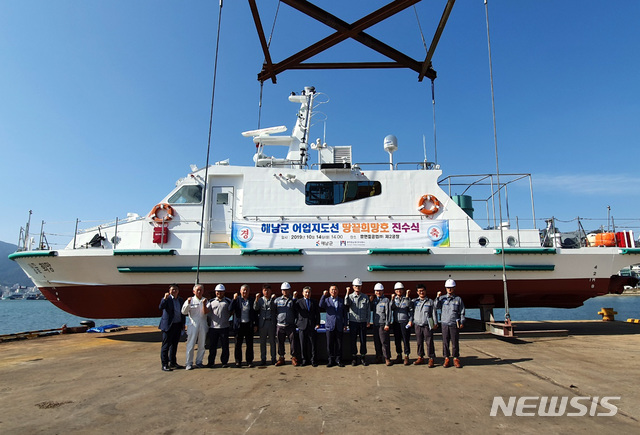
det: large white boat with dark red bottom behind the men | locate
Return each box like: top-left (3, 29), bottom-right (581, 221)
top-left (10, 87), bottom-right (640, 318)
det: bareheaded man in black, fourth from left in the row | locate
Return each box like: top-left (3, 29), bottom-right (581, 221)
top-left (231, 284), bottom-right (257, 368)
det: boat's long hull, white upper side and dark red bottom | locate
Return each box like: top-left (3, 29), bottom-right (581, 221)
top-left (15, 248), bottom-right (633, 319)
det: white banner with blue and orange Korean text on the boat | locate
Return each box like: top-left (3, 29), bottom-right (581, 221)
top-left (232, 221), bottom-right (449, 249)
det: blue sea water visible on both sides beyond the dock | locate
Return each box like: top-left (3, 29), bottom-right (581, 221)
top-left (0, 295), bottom-right (640, 335)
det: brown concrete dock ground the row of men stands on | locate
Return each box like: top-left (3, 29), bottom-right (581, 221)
top-left (0, 322), bottom-right (640, 434)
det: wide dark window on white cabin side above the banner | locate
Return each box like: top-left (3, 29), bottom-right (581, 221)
top-left (305, 181), bottom-right (382, 205)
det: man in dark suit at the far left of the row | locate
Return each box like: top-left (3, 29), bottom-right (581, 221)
top-left (158, 284), bottom-right (185, 372)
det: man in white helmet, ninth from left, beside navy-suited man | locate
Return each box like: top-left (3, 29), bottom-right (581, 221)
top-left (344, 278), bottom-right (371, 366)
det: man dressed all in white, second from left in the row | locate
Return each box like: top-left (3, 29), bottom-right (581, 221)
top-left (181, 284), bottom-right (208, 370)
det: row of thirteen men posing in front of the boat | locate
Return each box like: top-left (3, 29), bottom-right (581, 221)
top-left (159, 278), bottom-right (465, 371)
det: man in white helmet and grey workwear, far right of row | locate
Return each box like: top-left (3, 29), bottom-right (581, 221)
top-left (436, 279), bottom-right (465, 368)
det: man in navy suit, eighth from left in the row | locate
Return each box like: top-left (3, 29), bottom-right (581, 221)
top-left (320, 285), bottom-right (347, 367)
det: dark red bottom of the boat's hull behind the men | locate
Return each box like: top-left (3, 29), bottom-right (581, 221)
top-left (40, 275), bottom-right (631, 319)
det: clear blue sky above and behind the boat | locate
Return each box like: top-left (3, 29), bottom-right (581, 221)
top-left (0, 0), bottom-right (640, 243)
